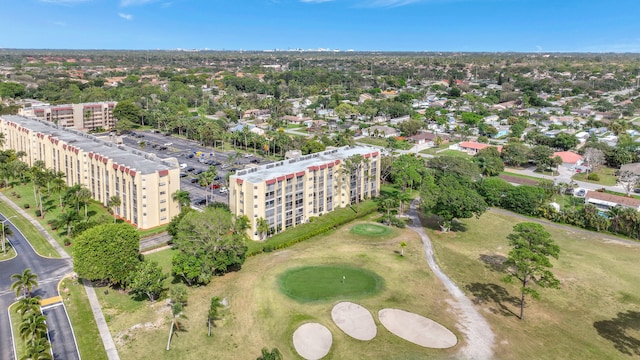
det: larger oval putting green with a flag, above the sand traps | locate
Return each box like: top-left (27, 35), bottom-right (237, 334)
top-left (278, 265), bottom-right (384, 302)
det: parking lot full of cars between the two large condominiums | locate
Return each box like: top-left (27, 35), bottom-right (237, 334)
top-left (123, 131), bottom-right (265, 207)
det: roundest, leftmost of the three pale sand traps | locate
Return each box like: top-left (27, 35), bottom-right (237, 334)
top-left (293, 323), bottom-right (333, 360)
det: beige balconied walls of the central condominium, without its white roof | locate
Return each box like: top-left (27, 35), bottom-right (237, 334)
top-left (229, 152), bottom-right (380, 240)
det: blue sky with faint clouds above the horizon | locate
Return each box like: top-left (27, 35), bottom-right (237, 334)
top-left (0, 0), bottom-right (640, 52)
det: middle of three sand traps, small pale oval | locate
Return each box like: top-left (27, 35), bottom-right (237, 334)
top-left (331, 302), bottom-right (377, 341)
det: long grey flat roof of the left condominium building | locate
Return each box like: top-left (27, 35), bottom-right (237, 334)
top-left (0, 115), bottom-right (178, 174)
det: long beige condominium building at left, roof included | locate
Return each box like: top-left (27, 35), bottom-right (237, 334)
top-left (0, 115), bottom-right (180, 229)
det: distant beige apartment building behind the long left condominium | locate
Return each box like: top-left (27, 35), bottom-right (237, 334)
top-left (19, 101), bottom-right (117, 131)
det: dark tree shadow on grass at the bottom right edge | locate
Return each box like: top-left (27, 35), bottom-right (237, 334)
top-left (593, 310), bottom-right (640, 356)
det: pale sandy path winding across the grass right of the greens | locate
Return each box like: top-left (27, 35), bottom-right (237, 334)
top-left (408, 198), bottom-right (495, 360)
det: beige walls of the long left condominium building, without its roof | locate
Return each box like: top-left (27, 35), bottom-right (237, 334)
top-left (0, 119), bottom-right (180, 229)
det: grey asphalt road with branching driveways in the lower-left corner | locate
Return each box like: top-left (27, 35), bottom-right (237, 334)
top-left (0, 215), bottom-right (80, 360)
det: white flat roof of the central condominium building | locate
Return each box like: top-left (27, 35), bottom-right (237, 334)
top-left (231, 146), bottom-right (380, 184)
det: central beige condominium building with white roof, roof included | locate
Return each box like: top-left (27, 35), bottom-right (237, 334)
top-left (229, 146), bottom-right (380, 240)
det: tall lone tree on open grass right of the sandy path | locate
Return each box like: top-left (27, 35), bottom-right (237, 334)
top-left (504, 223), bottom-right (560, 320)
